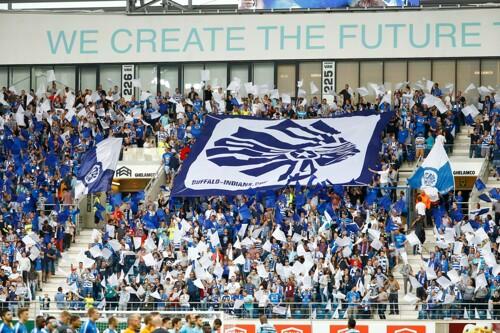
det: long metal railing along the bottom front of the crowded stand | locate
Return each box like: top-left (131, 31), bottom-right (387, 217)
top-left (2, 297), bottom-right (500, 320)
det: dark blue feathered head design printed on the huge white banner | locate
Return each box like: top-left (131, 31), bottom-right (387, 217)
top-left (206, 120), bottom-right (360, 182)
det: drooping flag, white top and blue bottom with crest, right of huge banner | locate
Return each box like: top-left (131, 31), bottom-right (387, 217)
top-left (408, 142), bottom-right (455, 193)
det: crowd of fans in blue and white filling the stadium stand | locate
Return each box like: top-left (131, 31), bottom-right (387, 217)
top-left (0, 76), bottom-right (500, 318)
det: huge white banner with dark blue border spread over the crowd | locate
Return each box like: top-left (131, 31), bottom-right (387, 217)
top-left (173, 112), bottom-right (393, 196)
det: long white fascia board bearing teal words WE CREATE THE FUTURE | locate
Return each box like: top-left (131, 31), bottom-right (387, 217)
top-left (0, 8), bottom-right (500, 65)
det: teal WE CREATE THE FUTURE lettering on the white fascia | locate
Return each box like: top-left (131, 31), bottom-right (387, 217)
top-left (46, 22), bottom-right (500, 55)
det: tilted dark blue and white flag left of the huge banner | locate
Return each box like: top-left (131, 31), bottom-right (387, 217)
top-left (75, 138), bottom-right (123, 199)
